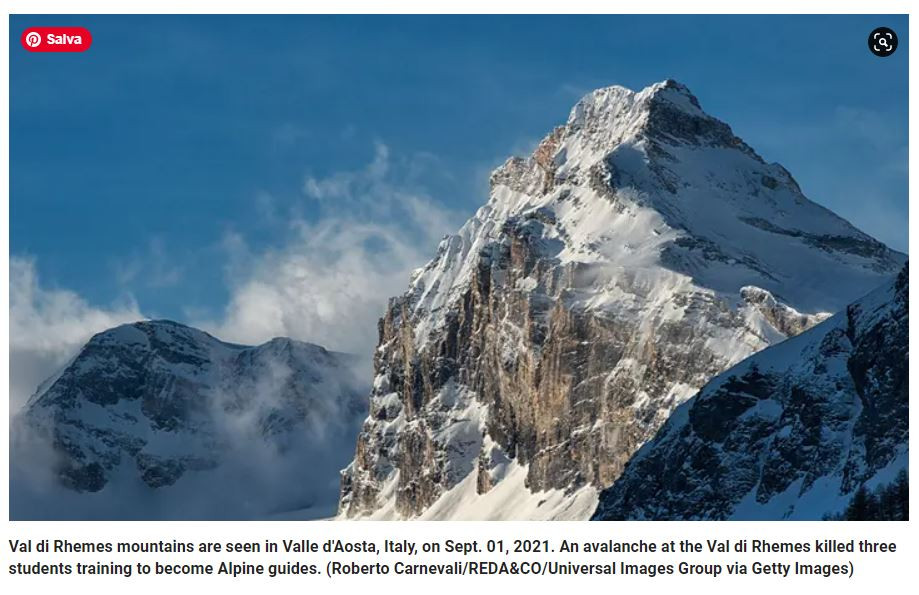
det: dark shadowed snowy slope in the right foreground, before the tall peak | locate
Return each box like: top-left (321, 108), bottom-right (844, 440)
top-left (594, 267), bottom-right (909, 520)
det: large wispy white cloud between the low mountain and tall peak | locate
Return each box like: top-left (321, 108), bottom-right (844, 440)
top-left (196, 143), bottom-right (459, 356)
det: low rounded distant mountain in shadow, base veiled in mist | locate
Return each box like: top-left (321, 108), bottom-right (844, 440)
top-left (12, 321), bottom-right (369, 518)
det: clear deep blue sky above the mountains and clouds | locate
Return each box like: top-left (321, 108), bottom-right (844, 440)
top-left (10, 16), bottom-right (908, 347)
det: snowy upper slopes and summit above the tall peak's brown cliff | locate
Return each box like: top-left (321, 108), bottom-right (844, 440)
top-left (409, 81), bottom-right (904, 344)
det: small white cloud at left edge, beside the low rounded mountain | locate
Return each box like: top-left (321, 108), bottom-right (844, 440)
top-left (10, 257), bottom-right (143, 413)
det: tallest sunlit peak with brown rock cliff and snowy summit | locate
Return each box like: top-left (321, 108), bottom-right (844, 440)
top-left (339, 81), bottom-right (905, 518)
